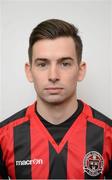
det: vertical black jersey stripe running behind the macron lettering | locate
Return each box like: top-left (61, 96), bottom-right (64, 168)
top-left (14, 121), bottom-right (31, 179)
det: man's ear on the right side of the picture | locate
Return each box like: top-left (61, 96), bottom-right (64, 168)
top-left (77, 62), bottom-right (86, 81)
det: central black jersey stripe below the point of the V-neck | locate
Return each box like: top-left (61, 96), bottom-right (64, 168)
top-left (49, 143), bottom-right (68, 179)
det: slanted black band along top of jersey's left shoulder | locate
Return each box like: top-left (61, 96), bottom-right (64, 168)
top-left (0, 108), bottom-right (27, 128)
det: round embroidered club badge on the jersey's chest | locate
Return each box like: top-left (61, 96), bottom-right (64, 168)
top-left (83, 151), bottom-right (104, 176)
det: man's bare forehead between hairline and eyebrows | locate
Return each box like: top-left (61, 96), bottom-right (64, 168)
top-left (32, 37), bottom-right (76, 59)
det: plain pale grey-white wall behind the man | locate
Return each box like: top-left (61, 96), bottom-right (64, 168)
top-left (0, 0), bottom-right (112, 120)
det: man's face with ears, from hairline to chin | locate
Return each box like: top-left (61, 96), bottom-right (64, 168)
top-left (26, 37), bottom-right (85, 104)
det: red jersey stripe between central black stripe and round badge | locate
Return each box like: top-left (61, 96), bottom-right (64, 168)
top-left (67, 116), bottom-right (86, 179)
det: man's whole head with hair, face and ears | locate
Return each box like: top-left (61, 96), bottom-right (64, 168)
top-left (25, 19), bottom-right (86, 104)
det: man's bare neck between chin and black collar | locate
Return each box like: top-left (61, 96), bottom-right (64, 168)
top-left (37, 97), bottom-right (78, 124)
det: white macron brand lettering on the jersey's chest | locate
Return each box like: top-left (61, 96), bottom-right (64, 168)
top-left (16, 159), bottom-right (43, 166)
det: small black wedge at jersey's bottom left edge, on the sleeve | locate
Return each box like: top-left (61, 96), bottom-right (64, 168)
top-left (0, 148), bottom-right (8, 179)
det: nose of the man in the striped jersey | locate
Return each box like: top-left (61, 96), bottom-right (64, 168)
top-left (48, 65), bottom-right (60, 83)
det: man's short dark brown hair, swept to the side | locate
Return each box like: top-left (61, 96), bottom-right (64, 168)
top-left (28, 19), bottom-right (83, 64)
